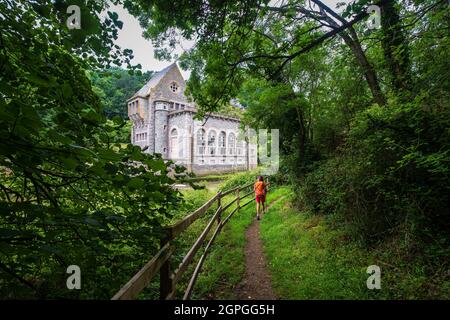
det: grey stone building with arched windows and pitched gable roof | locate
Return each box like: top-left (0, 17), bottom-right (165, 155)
top-left (127, 63), bottom-right (257, 174)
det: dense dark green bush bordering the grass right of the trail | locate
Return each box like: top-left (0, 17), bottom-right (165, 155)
top-left (300, 102), bottom-right (450, 250)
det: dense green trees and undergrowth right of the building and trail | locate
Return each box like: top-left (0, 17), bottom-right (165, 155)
top-left (156, 1), bottom-right (450, 245)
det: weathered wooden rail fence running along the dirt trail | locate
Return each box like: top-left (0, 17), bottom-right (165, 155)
top-left (112, 183), bottom-right (253, 300)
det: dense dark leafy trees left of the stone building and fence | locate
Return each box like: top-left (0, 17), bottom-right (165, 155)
top-left (0, 1), bottom-right (180, 299)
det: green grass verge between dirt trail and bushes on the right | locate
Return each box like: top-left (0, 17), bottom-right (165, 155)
top-left (260, 189), bottom-right (449, 299)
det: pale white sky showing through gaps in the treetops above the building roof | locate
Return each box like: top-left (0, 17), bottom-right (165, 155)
top-left (110, 0), bottom-right (342, 80)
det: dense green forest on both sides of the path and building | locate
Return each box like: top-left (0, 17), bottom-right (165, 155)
top-left (0, 0), bottom-right (450, 299)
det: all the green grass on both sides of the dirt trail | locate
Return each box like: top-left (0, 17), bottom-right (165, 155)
top-left (141, 177), bottom-right (450, 299)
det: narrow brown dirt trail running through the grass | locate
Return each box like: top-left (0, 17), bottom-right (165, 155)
top-left (236, 197), bottom-right (284, 300)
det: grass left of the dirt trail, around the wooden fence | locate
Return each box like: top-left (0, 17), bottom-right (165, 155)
top-left (140, 178), bottom-right (255, 299)
